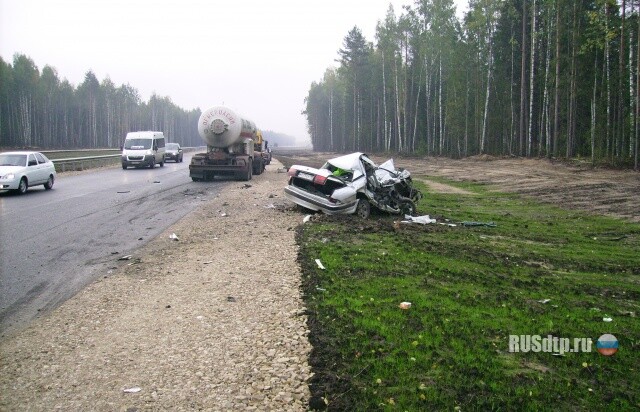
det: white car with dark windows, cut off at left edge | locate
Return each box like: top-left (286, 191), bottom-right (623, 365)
top-left (0, 151), bottom-right (56, 194)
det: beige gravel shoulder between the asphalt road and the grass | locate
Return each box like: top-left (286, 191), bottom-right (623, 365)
top-left (0, 160), bottom-right (311, 410)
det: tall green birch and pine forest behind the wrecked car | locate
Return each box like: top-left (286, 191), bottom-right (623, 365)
top-left (304, 0), bottom-right (640, 170)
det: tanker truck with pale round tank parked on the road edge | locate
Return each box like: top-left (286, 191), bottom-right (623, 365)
top-left (189, 106), bottom-right (265, 182)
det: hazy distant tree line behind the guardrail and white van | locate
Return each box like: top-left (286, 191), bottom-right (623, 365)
top-left (0, 54), bottom-right (202, 149)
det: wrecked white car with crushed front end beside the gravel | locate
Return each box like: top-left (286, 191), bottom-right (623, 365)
top-left (284, 153), bottom-right (422, 218)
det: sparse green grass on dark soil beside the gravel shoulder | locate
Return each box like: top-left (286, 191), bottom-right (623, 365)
top-left (298, 179), bottom-right (640, 411)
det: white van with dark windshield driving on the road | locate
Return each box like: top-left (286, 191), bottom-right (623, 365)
top-left (122, 132), bottom-right (165, 169)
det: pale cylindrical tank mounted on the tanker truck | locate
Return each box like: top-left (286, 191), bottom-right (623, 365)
top-left (198, 106), bottom-right (256, 148)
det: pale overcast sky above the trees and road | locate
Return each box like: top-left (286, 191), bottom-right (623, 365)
top-left (0, 0), bottom-right (467, 144)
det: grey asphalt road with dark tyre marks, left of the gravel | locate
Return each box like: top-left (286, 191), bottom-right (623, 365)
top-left (0, 154), bottom-right (226, 334)
